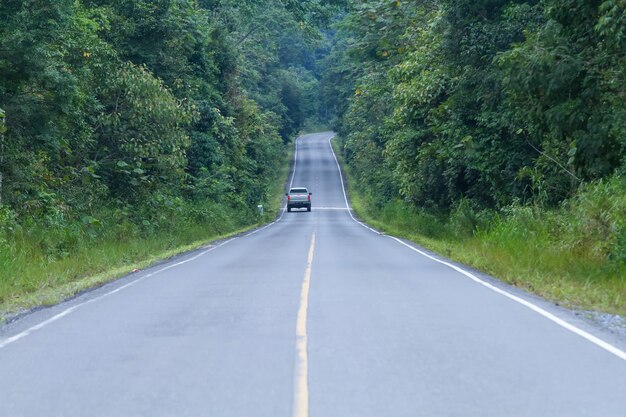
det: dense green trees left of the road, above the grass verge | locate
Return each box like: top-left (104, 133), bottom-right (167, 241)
top-left (0, 0), bottom-right (336, 227)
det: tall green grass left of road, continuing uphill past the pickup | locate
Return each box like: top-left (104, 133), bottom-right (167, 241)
top-left (0, 141), bottom-right (293, 322)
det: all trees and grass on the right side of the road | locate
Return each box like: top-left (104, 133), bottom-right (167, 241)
top-left (321, 0), bottom-right (626, 314)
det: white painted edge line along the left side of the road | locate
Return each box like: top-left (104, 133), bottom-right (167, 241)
top-left (0, 134), bottom-right (308, 349)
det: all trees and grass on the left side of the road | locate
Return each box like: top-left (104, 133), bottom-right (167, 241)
top-left (0, 0), bottom-right (336, 311)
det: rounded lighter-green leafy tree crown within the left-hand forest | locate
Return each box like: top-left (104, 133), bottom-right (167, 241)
top-left (93, 64), bottom-right (194, 200)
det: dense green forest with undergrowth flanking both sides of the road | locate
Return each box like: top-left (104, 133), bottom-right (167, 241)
top-left (0, 0), bottom-right (626, 312)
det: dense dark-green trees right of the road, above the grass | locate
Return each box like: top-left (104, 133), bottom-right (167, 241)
top-left (322, 0), bottom-right (626, 211)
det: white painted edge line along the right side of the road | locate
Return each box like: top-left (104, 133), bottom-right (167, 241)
top-left (328, 137), bottom-right (626, 361)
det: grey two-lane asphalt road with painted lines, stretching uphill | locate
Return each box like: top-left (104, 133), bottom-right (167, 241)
top-left (0, 133), bottom-right (626, 417)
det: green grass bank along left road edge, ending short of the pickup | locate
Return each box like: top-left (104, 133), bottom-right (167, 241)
top-left (0, 206), bottom-right (255, 320)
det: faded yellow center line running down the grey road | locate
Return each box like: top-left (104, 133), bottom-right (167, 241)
top-left (293, 232), bottom-right (315, 417)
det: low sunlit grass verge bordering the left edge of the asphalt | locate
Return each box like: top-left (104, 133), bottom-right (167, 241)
top-left (0, 224), bottom-right (255, 322)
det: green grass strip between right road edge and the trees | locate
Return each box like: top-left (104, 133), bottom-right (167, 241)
top-left (334, 137), bottom-right (626, 315)
